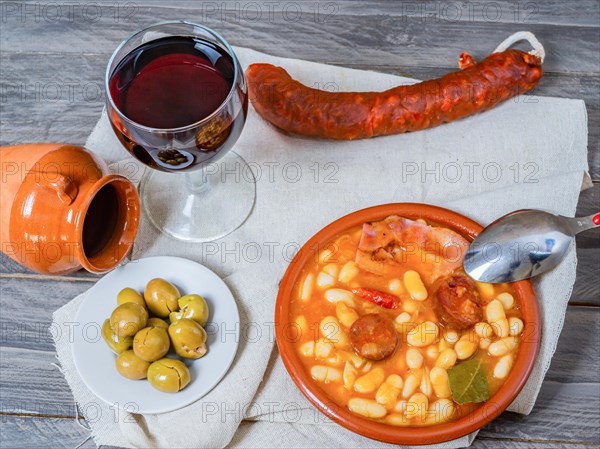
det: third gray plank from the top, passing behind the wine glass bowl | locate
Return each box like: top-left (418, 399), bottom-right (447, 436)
top-left (0, 53), bottom-right (600, 180)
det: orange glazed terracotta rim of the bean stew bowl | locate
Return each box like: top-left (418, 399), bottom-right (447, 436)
top-left (275, 203), bottom-right (541, 445)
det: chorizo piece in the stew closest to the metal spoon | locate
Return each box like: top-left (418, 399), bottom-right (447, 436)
top-left (435, 274), bottom-right (483, 329)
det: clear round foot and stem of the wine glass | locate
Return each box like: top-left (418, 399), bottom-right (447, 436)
top-left (140, 151), bottom-right (256, 242)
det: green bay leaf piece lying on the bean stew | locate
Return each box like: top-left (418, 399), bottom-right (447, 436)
top-left (448, 357), bottom-right (490, 404)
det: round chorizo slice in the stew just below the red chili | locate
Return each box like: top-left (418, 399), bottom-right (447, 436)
top-left (350, 313), bottom-right (398, 360)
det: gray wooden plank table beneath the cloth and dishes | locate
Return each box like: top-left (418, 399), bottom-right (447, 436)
top-left (0, 0), bottom-right (600, 449)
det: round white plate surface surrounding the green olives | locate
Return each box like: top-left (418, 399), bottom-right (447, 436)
top-left (72, 257), bottom-right (240, 414)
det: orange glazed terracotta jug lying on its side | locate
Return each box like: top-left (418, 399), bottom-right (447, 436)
top-left (0, 144), bottom-right (140, 274)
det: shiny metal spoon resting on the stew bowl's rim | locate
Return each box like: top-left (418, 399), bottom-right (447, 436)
top-left (464, 209), bottom-right (600, 283)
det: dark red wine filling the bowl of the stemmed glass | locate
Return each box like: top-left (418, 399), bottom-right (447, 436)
top-left (109, 37), bottom-right (247, 171)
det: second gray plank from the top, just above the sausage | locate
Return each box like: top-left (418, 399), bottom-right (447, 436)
top-left (0, 6), bottom-right (600, 73)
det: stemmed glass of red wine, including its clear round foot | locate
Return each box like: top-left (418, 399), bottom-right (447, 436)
top-left (106, 21), bottom-right (255, 242)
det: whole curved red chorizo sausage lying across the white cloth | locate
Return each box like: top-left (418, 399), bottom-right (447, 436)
top-left (246, 43), bottom-right (543, 140)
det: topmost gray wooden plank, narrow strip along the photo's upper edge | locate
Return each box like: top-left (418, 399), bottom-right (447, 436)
top-left (4, 0), bottom-right (600, 27)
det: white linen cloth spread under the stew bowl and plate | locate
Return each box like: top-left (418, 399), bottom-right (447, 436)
top-left (54, 43), bottom-right (589, 448)
